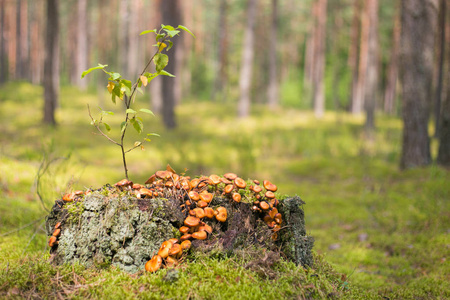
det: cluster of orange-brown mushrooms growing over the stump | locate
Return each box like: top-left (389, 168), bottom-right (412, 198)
top-left (49, 165), bottom-right (282, 272)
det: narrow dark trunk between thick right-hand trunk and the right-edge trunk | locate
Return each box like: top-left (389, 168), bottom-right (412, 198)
top-left (434, 0), bottom-right (447, 137)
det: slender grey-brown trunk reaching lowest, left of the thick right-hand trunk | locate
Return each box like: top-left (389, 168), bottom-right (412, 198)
top-left (364, 0), bottom-right (378, 134)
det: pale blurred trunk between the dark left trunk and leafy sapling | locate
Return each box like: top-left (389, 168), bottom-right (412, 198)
top-left (75, 0), bottom-right (88, 90)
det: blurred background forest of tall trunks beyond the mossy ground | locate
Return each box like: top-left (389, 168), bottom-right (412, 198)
top-left (0, 0), bottom-right (449, 166)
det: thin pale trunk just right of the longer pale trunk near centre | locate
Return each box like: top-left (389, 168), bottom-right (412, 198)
top-left (267, 0), bottom-right (279, 108)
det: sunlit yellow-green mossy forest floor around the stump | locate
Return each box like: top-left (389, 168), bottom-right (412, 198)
top-left (0, 83), bottom-right (450, 299)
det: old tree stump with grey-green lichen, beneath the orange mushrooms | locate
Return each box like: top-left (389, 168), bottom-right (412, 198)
top-left (46, 185), bottom-right (314, 273)
